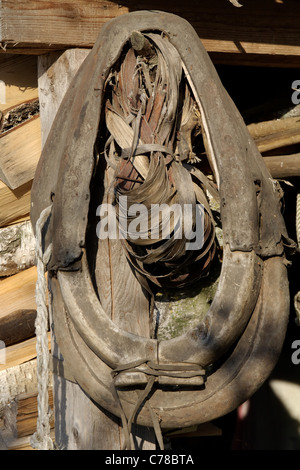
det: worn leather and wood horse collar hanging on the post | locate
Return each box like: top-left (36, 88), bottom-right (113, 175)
top-left (31, 12), bottom-right (289, 428)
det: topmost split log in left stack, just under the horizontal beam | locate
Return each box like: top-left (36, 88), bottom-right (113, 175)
top-left (0, 55), bottom-right (38, 112)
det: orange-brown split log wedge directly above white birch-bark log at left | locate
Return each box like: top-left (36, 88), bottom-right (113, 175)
top-left (0, 180), bottom-right (32, 227)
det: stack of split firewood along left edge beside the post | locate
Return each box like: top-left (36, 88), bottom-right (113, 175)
top-left (0, 54), bottom-right (52, 449)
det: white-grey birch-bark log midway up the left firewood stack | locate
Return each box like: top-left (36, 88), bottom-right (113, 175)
top-left (0, 221), bottom-right (35, 277)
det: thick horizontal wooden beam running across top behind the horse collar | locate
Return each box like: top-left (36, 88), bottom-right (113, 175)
top-left (0, 0), bottom-right (300, 67)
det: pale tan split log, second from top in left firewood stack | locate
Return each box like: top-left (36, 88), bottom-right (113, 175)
top-left (0, 115), bottom-right (41, 189)
